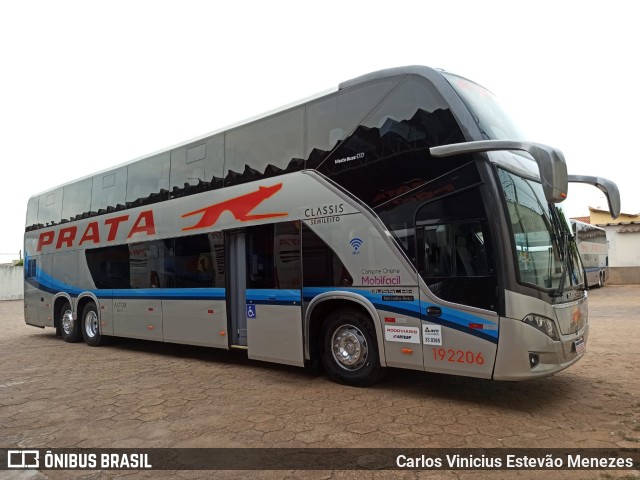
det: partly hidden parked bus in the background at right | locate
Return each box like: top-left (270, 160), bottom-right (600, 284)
top-left (570, 219), bottom-right (609, 287)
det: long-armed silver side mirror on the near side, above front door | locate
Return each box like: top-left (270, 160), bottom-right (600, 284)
top-left (429, 140), bottom-right (568, 203)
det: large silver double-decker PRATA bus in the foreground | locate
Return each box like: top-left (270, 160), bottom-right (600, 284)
top-left (24, 66), bottom-right (620, 386)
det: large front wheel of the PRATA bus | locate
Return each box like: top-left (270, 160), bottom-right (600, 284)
top-left (322, 309), bottom-right (384, 387)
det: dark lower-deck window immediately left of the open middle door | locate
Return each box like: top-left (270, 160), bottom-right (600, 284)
top-left (173, 233), bottom-right (225, 288)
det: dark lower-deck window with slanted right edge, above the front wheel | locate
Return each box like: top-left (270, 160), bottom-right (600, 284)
top-left (302, 224), bottom-right (353, 287)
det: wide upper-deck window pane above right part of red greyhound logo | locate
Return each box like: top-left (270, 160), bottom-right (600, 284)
top-left (224, 108), bottom-right (304, 186)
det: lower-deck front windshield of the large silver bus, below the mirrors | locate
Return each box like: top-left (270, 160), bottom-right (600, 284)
top-left (498, 169), bottom-right (584, 295)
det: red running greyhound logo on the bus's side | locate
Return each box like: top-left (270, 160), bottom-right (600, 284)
top-left (182, 183), bottom-right (288, 230)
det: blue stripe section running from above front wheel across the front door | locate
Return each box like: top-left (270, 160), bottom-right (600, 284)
top-left (303, 287), bottom-right (498, 344)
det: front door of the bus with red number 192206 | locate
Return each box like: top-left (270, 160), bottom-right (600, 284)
top-left (416, 189), bottom-right (499, 378)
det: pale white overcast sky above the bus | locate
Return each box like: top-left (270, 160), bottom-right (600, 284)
top-left (0, 0), bottom-right (640, 263)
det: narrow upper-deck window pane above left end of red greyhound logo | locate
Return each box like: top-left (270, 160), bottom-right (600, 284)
top-left (170, 135), bottom-right (224, 197)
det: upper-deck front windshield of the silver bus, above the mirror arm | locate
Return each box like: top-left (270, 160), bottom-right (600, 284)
top-left (443, 73), bottom-right (527, 140)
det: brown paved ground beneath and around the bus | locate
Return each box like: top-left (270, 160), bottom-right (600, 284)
top-left (0, 285), bottom-right (640, 480)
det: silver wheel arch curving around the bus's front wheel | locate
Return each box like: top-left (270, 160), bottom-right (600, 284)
top-left (304, 291), bottom-right (387, 367)
